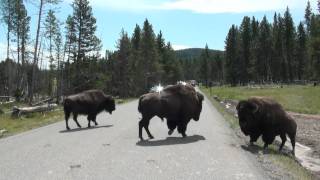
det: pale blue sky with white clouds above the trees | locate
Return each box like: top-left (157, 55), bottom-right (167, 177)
top-left (0, 0), bottom-right (317, 59)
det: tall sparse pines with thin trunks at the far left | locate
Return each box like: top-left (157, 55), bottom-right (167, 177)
top-left (0, 0), bottom-right (101, 103)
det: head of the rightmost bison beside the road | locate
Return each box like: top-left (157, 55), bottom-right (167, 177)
top-left (237, 101), bottom-right (259, 135)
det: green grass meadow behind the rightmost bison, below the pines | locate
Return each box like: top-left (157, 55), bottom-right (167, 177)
top-left (202, 85), bottom-right (320, 114)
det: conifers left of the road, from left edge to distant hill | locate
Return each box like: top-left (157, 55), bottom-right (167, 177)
top-left (0, 0), bottom-right (183, 100)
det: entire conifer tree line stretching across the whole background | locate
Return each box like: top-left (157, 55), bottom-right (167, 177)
top-left (0, 0), bottom-right (320, 103)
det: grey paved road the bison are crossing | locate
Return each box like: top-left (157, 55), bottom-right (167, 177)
top-left (0, 92), bottom-right (267, 180)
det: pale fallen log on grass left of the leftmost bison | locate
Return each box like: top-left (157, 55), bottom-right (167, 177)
top-left (11, 104), bottom-right (58, 117)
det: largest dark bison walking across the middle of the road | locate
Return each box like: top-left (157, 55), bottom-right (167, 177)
top-left (138, 84), bottom-right (204, 140)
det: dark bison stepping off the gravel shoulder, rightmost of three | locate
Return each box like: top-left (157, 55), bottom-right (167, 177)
top-left (237, 97), bottom-right (297, 155)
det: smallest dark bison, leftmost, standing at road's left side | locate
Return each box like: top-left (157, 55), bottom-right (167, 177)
top-left (64, 90), bottom-right (116, 130)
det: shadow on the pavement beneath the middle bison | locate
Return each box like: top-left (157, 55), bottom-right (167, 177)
top-left (136, 135), bottom-right (206, 146)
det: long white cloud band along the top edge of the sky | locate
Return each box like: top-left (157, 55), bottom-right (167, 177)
top-left (65, 0), bottom-right (316, 13)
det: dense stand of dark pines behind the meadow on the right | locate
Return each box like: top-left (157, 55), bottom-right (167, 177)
top-left (224, 2), bottom-right (320, 85)
